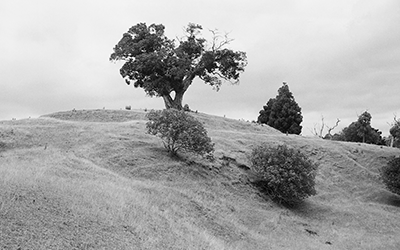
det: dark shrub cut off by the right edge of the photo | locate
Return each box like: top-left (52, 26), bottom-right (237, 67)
top-left (381, 157), bottom-right (400, 195)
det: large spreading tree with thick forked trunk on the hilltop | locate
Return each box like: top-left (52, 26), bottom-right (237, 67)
top-left (110, 23), bottom-right (247, 109)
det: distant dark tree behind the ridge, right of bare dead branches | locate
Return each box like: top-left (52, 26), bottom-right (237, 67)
top-left (332, 111), bottom-right (384, 145)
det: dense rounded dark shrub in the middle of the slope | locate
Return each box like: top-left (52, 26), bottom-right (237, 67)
top-left (250, 144), bottom-right (317, 204)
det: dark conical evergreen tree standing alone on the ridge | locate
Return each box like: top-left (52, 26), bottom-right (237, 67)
top-left (258, 82), bottom-right (303, 135)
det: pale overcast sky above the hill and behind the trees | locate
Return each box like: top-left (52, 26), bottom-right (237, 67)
top-left (0, 0), bottom-right (400, 135)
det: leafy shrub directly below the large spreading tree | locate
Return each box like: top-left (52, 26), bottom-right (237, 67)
top-left (146, 109), bottom-right (214, 157)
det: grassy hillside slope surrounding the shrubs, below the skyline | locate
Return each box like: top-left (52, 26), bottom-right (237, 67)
top-left (0, 110), bottom-right (400, 250)
